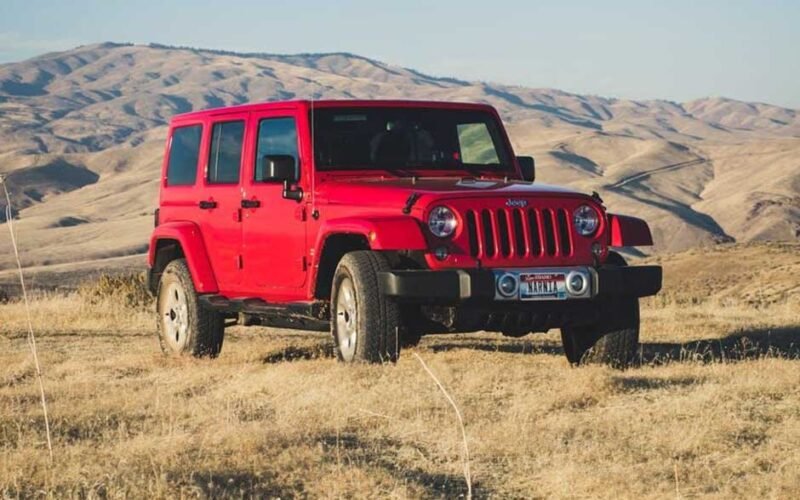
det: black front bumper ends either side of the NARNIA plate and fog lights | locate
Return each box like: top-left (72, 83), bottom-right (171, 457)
top-left (379, 266), bottom-right (662, 303)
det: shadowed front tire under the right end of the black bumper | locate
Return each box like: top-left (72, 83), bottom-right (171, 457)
top-left (561, 252), bottom-right (639, 369)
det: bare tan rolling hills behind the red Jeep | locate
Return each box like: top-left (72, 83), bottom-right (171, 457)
top-left (0, 43), bottom-right (800, 270)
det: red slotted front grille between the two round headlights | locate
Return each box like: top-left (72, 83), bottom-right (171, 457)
top-left (465, 208), bottom-right (573, 259)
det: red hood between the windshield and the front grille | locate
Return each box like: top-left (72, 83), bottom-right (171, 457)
top-left (317, 177), bottom-right (587, 207)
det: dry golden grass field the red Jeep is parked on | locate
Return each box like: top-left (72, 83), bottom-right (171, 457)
top-left (0, 245), bottom-right (800, 498)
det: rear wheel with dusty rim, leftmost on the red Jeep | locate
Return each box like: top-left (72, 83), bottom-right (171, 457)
top-left (156, 259), bottom-right (225, 358)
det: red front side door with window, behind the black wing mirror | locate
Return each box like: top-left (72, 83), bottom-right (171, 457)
top-left (242, 110), bottom-right (310, 300)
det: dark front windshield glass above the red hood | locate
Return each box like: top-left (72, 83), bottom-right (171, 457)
top-left (313, 107), bottom-right (513, 173)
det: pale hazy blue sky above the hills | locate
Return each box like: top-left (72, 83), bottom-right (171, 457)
top-left (0, 0), bottom-right (800, 108)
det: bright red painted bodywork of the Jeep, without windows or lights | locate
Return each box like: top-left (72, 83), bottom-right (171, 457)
top-left (150, 97), bottom-right (652, 302)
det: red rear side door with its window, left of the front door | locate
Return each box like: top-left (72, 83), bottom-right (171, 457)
top-left (197, 113), bottom-right (248, 297)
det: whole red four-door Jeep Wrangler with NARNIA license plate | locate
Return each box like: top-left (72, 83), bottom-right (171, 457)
top-left (149, 101), bottom-right (661, 366)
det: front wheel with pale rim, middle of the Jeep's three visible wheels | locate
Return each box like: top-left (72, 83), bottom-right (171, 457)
top-left (331, 250), bottom-right (400, 363)
